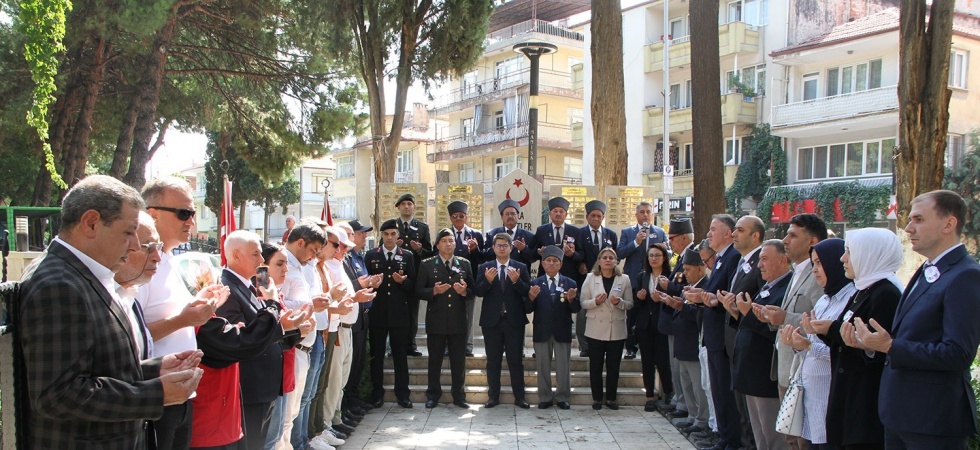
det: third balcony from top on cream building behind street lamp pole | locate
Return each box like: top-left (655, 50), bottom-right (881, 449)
top-left (426, 122), bottom-right (573, 163)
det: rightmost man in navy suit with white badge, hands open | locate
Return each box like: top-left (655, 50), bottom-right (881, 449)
top-left (841, 190), bottom-right (980, 449)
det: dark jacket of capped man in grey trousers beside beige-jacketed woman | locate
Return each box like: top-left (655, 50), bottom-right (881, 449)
top-left (531, 274), bottom-right (582, 342)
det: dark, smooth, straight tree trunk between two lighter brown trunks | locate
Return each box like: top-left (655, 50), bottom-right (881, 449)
top-left (688, 0), bottom-right (725, 237)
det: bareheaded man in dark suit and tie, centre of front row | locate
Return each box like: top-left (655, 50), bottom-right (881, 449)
top-left (476, 233), bottom-right (533, 409)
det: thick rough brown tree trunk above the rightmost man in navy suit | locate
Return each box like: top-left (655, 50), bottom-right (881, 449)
top-left (895, 0), bottom-right (954, 227)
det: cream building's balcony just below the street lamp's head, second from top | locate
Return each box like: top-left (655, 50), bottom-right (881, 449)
top-left (432, 69), bottom-right (582, 116)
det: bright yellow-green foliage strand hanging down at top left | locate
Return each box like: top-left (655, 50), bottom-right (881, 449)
top-left (19, 0), bottom-right (72, 188)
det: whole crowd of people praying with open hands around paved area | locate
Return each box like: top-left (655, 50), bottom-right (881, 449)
top-left (17, 175), bottom-right (980, 450)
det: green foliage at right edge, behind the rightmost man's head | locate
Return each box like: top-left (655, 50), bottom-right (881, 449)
top-left (943, 128), bottom-right (980, 258)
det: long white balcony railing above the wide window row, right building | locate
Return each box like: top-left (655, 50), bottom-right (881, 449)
top-left (771, 86), bottom-right (898, 128)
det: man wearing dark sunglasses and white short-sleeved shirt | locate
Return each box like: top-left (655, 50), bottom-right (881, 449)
top-left (137, 177), bottom-right (217, 450)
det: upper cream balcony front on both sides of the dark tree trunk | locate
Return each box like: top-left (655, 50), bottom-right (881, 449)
top-left (645, 22), bottom-right (759, 73)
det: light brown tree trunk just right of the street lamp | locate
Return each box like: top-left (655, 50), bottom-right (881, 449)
top-left (590, 0), bottom-right (628, 190)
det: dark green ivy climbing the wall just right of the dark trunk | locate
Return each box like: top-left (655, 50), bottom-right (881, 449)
top-left (725, 123), bottom-right (786, 215)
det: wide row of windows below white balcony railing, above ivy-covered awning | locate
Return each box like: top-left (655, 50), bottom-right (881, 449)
top-left (796, 139), bottom-right (895, 180)
